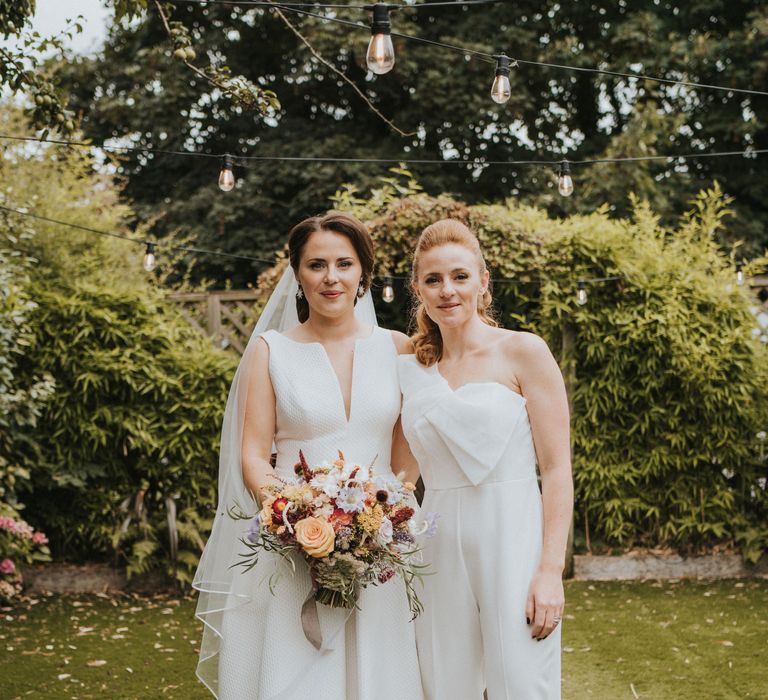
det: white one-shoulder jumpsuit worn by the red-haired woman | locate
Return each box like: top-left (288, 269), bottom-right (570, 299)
top-left (399, 355), bottom-right (562, 700)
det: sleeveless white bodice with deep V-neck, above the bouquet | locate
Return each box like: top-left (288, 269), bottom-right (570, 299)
top-left (262, 327), bottom-right (400, 474)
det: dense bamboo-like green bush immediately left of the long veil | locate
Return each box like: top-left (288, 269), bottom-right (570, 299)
top-left (20, 283), bottom-right (235, 580)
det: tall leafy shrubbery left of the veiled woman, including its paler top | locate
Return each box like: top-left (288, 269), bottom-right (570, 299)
top-left (0, 108), bottom-right (236, 581)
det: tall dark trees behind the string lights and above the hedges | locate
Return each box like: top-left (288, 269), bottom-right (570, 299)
top-left (57, 0), bottom-right (768, 285)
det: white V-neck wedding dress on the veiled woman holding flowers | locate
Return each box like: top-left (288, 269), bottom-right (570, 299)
top-left (213, 327), bottom-right (423, 700)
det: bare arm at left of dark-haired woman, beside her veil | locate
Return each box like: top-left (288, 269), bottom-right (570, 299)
top-left (241, 338), bottom-right (277, 500)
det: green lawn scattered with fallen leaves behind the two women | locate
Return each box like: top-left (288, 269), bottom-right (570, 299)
top-left (0, 580), bottom-right (768, 700)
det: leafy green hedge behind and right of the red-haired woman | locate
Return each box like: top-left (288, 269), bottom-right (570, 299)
top-left (335, 173), bottom-right (768, 561)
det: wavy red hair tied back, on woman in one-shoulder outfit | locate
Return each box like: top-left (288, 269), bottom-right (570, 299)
top-left (411, 219), bottom-right (499, 366)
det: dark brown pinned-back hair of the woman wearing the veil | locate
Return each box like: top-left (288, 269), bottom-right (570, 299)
top-left (288, 212), bottom-right (375, 323)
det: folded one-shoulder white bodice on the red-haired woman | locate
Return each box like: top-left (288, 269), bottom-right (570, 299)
top-left (399, 355), bottom-right (536, 489)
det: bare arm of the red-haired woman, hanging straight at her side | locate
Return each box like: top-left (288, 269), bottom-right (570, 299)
top-left (510, 333), bottom-right (573, 639)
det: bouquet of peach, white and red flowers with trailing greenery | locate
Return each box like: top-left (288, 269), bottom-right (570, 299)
top-left (230, 452), bottom-right (434, 617)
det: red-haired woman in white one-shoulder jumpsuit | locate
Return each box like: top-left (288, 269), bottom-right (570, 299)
top-left (398, 220), bottom-right (573, 700)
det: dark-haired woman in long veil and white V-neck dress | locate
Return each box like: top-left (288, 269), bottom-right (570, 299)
top-left (193, 213), bottom-right (423, 700)
